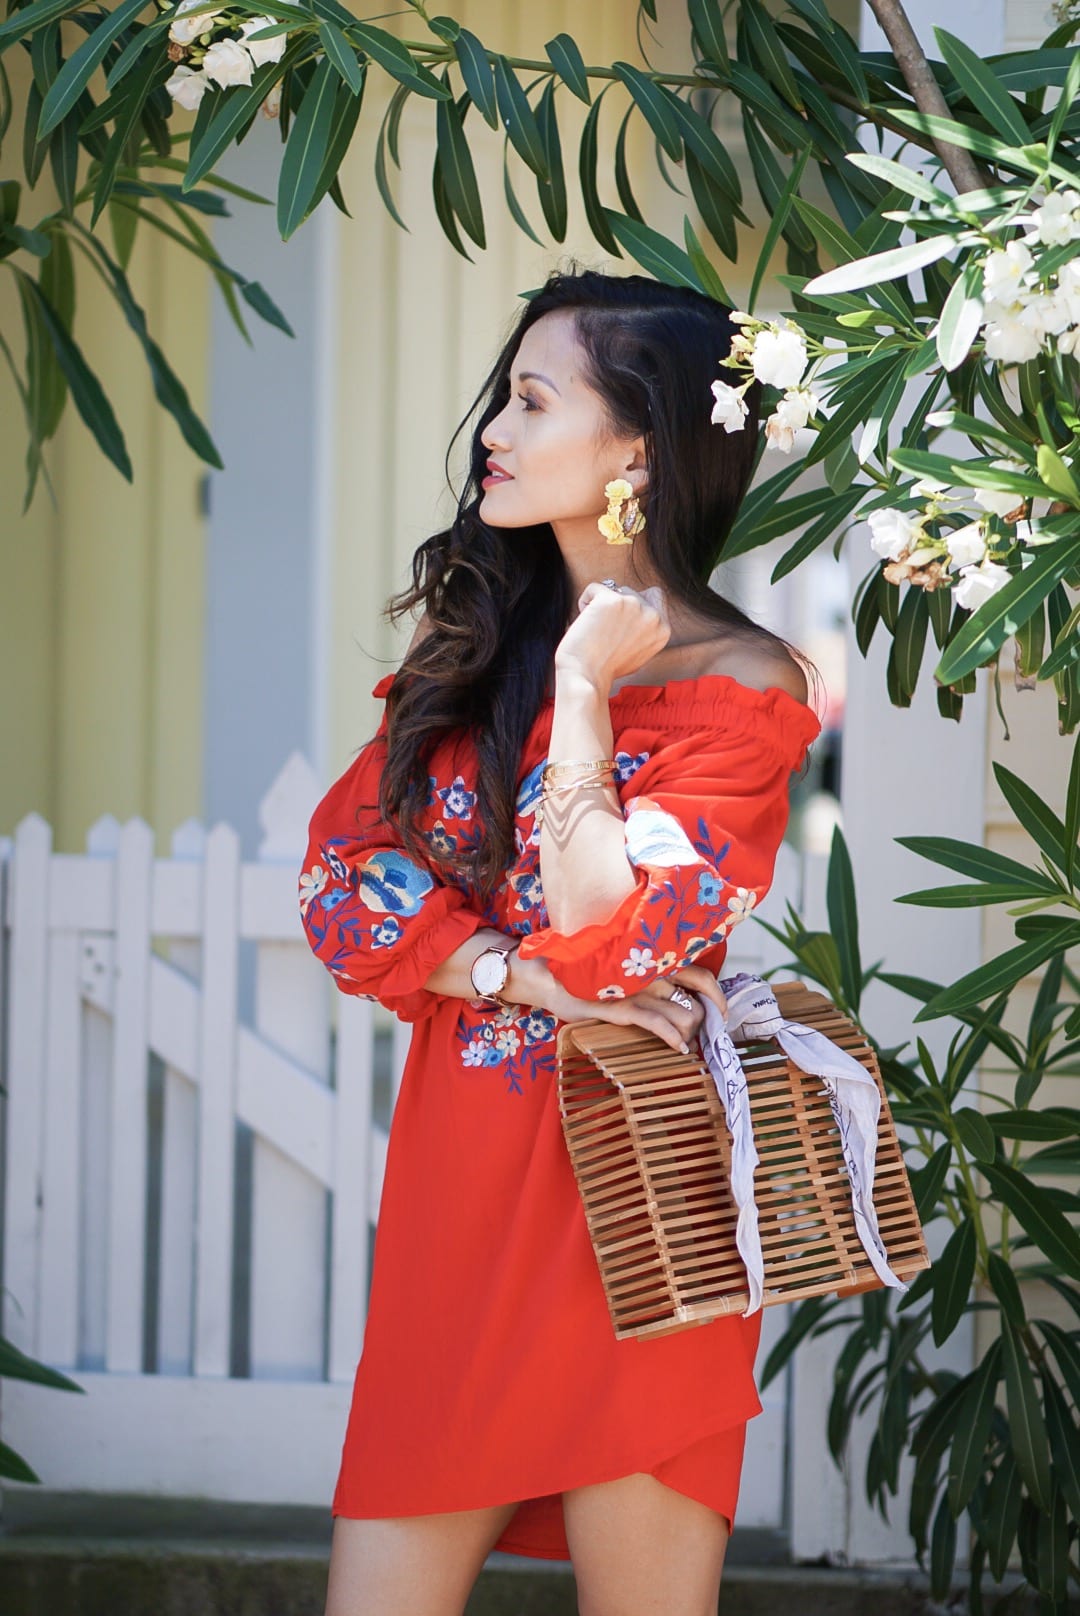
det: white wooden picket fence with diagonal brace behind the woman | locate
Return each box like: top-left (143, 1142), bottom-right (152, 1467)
top-left (0, 753), bottom-right (799, 1526)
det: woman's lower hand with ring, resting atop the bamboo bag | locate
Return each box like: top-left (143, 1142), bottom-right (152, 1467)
top-left (504, 960), bottom-right (728, 1054)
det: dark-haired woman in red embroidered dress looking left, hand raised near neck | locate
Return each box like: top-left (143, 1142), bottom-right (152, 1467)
top-left (301, 271), bottom-right (820, 1616)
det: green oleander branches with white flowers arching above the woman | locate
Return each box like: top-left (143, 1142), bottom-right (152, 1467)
top-left (0, 0), bottom-right (1080, 733)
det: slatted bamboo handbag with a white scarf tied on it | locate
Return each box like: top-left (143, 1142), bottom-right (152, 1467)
top-left (558, 983), bottom-right (930, 1338)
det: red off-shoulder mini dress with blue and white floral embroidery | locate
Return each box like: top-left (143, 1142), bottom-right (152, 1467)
top-left (301, 674), bottom-right (820, 1558)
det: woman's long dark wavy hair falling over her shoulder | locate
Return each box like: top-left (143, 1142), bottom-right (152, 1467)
top-left (378, 270), bottom-right (808, 894)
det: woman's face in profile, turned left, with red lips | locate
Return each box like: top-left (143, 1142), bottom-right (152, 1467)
top-left (479, 309), bottom-right (645, 537)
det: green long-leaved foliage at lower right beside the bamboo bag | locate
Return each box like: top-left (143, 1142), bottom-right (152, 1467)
top-left (758, 827), bottom-right (1080, 1611)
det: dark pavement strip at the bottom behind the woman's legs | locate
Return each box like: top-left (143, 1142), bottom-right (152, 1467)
top-left (0, 1488), bottom-right (1080, 1616)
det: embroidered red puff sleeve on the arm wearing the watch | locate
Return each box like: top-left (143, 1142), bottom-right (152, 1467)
top-left (292, 679), bottom-right (485, 1021)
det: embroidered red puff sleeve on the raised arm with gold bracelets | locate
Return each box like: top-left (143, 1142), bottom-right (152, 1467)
top-left (521, 692), bottom-right (820, 1000)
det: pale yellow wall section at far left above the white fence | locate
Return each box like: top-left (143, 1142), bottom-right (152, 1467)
top-left (0, 52), bottom-right (210, 850)
